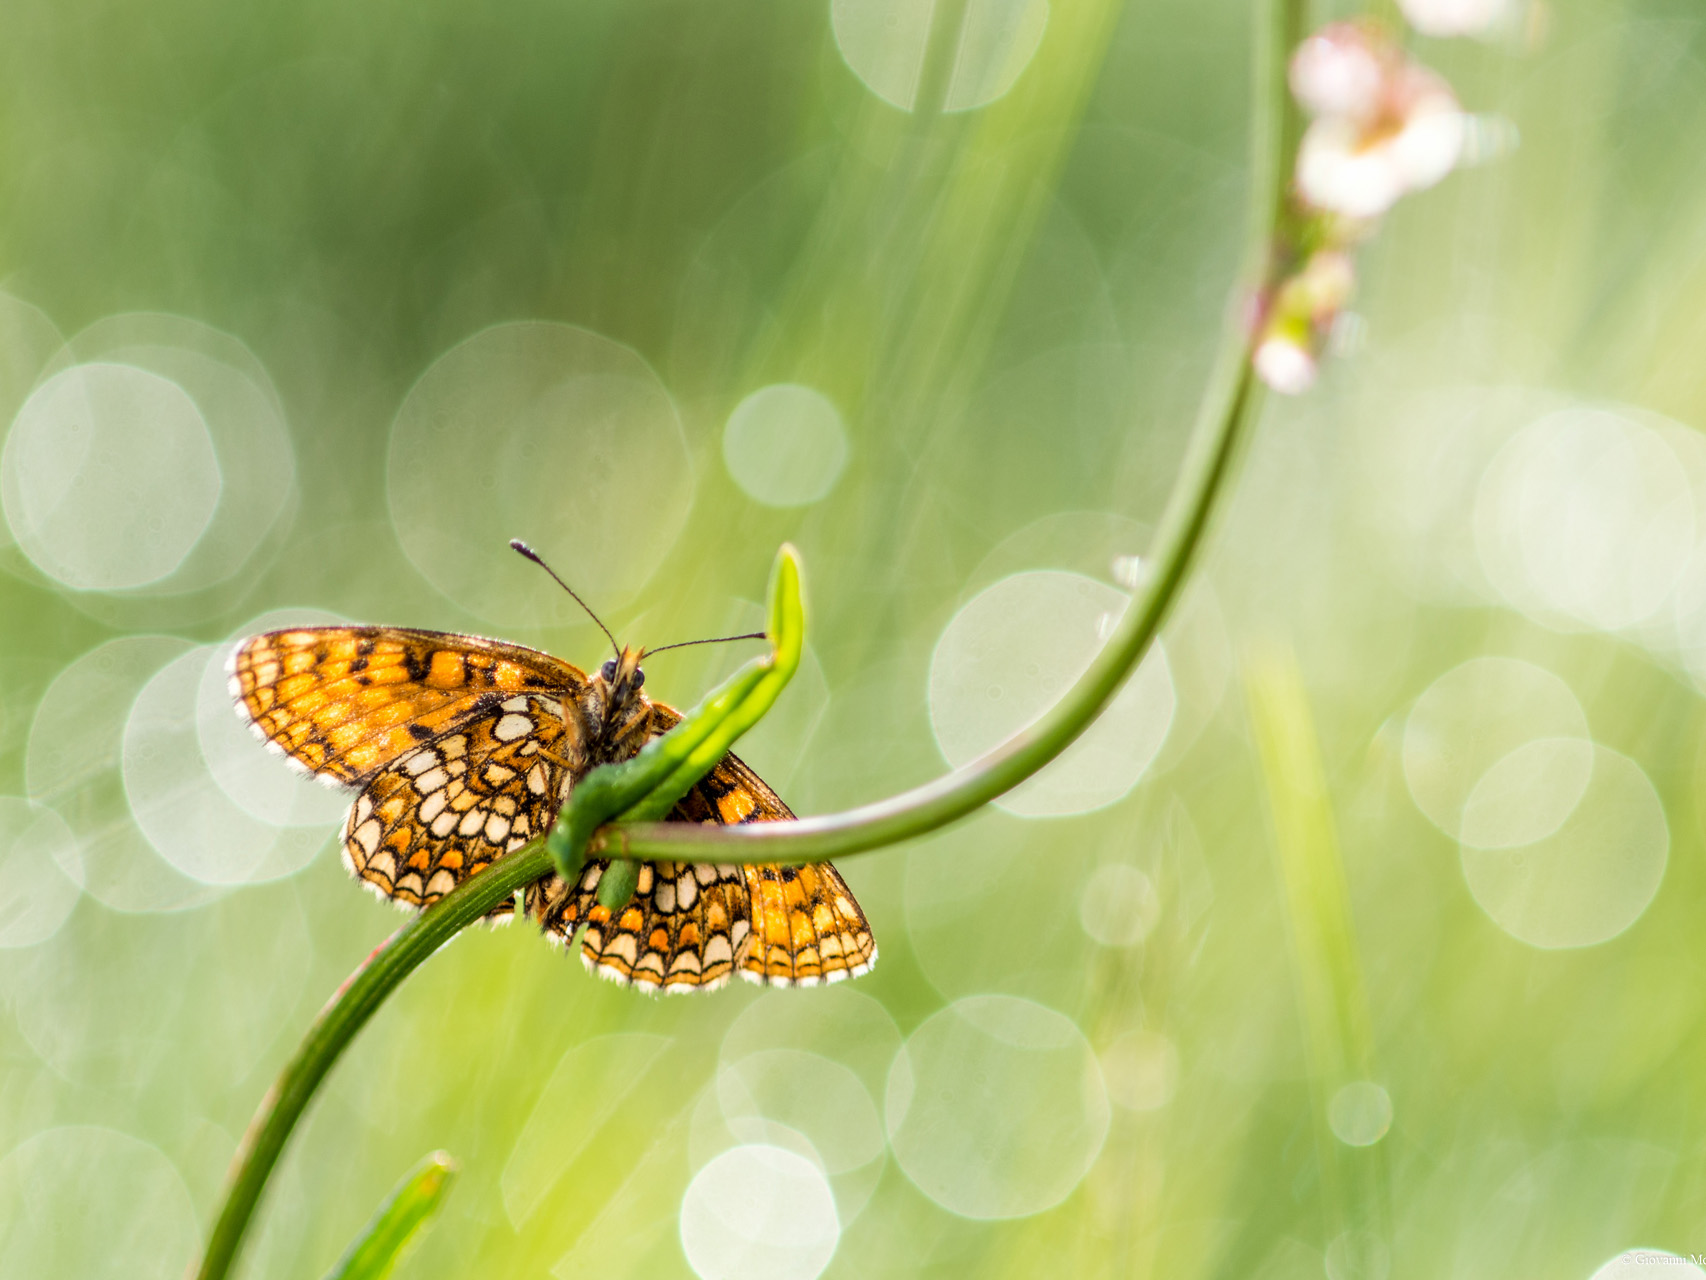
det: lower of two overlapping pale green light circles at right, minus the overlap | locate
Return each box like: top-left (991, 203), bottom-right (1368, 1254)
top-left (1462, 746), bottom-right (1670, 949)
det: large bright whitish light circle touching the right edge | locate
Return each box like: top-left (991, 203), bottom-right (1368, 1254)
top-left (1474, 408), bottom-right (1696, 630)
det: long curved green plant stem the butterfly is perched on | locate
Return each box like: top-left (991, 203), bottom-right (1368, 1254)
top-left (198, 0), bottom-right (1303, 1280)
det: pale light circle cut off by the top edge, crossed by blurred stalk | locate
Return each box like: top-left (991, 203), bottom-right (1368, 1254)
top-left (829, 0), bottom-right (1049, 111)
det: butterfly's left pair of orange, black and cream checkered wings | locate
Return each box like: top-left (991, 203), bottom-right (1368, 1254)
top-left (230, 626), bottom-right (585, 915)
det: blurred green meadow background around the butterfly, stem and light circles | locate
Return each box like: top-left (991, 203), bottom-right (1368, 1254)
top-left (0, 0), bottom-right (1706, 1280)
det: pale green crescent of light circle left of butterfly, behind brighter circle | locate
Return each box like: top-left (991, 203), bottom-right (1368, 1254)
top-left (24, 635), bottom-right (220, 911)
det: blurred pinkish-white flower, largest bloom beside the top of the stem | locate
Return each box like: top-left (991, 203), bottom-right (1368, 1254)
top-left (1297, 65), bottom-right (1465, 218)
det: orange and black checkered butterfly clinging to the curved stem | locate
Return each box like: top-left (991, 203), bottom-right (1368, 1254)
top-left (229, 628), bottom-right (877, 992)
